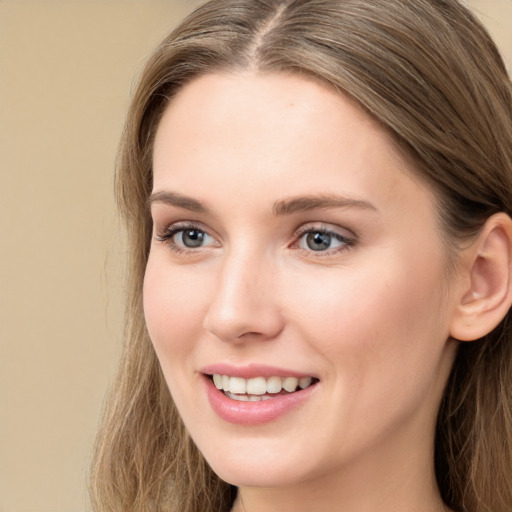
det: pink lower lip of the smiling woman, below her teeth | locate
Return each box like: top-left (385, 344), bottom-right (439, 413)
top-left (205, 376), bottom-right (317, 425)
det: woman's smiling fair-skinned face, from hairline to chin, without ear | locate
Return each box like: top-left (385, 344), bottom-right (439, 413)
top-left (144, 73), bottom-right (456, 487)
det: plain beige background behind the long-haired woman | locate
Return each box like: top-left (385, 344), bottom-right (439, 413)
top-left (0, 0), bottom-right (512, 512)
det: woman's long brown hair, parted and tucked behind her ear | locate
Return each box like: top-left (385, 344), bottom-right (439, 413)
top-left (91, 0), bottom-right (512, 512)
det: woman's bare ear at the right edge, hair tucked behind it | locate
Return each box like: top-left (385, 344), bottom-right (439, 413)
top-left (450, 213), bottom-right (512, 341)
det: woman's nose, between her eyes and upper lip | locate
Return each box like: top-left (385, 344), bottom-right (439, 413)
top-left (204, 250), bottom-right (284, 342)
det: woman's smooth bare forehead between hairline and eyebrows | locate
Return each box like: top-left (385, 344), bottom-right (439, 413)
top-left (153, 73), bottom-right (427, 216)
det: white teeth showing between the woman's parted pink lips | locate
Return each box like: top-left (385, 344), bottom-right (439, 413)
top-left (210, 373), bottom-right (318, 402)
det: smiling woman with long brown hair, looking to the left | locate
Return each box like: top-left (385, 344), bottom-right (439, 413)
top-left (92, 0), bottom-right (512, 512)
